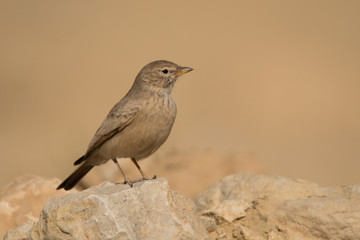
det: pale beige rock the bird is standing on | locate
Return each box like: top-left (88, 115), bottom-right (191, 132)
top-left (5, 178), bottom-right (208, 240)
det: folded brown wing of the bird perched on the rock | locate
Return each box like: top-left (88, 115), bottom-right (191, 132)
top-left (85, 105), bottom-right (140, 157)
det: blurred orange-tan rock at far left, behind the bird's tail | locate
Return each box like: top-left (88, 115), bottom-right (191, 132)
top-left (0, 175), bottom-right (74, 235)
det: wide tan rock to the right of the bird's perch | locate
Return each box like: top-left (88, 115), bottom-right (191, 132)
top-left (195, 174), bottom-right (360, 240)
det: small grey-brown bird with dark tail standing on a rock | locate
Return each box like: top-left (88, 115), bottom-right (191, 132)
top-left (57, 60), bottom-right (193, 190)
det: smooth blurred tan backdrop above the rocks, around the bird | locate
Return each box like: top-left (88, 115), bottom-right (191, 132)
top-left (0, 0), bottom-right (360, 192)
